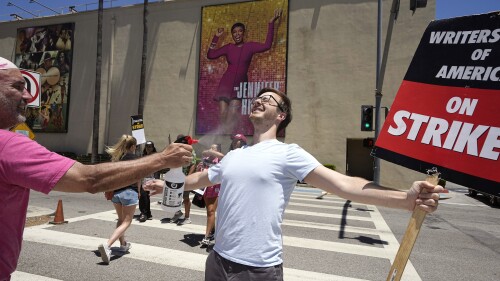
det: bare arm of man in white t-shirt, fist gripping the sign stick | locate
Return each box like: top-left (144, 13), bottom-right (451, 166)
top-left (304, 166), bottom-right (444, 213)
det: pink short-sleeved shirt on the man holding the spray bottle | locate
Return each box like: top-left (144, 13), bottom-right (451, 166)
top-left (0, 130), bottom-right (75, 280)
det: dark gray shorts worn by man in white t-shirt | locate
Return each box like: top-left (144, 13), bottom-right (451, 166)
top-left (205, 251), bottom-right (283, 281)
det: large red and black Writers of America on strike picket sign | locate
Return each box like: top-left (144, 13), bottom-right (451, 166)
top-left (373, 13), bottom-right (500, 194)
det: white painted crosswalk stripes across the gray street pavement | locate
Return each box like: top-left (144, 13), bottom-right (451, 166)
top-left (12, 186), bottom-right (421, 281)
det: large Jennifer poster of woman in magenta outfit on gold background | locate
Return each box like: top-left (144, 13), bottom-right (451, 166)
top-left (196, 0), bottom-right (288, 136)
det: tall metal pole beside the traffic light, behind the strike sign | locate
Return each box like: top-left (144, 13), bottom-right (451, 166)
top-left (373, 0), bottom-right (400, 184)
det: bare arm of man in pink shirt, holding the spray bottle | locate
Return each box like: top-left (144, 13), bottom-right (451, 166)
top-left (54, 143), bottom-right (193, 193)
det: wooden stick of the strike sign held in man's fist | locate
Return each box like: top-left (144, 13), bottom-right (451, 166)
top-left (386, 168), bottom-right (439, 281)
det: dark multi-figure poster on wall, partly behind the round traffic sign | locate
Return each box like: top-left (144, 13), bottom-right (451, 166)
top-left (14, 23), bottom-right (75, 133)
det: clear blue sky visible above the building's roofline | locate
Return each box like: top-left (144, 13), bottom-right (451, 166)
top-left (0, 0), bottom-right (500, 22)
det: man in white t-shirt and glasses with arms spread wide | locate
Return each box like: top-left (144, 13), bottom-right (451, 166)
top-left (146, 88), bottom-right (443, 281)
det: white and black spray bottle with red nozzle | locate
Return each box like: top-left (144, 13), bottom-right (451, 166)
top-left (161, 136), bottom-right (198, 216)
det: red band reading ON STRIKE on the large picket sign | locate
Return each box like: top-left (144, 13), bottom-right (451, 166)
top-left (376, 81), bottom-right (500, 182)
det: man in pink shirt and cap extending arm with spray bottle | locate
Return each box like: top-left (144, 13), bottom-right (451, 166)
top-left (0, 57), bottom-right (192, 281)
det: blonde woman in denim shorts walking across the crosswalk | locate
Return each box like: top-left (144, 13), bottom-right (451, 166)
top-left (98, 135), bottom-right (141, 263)
